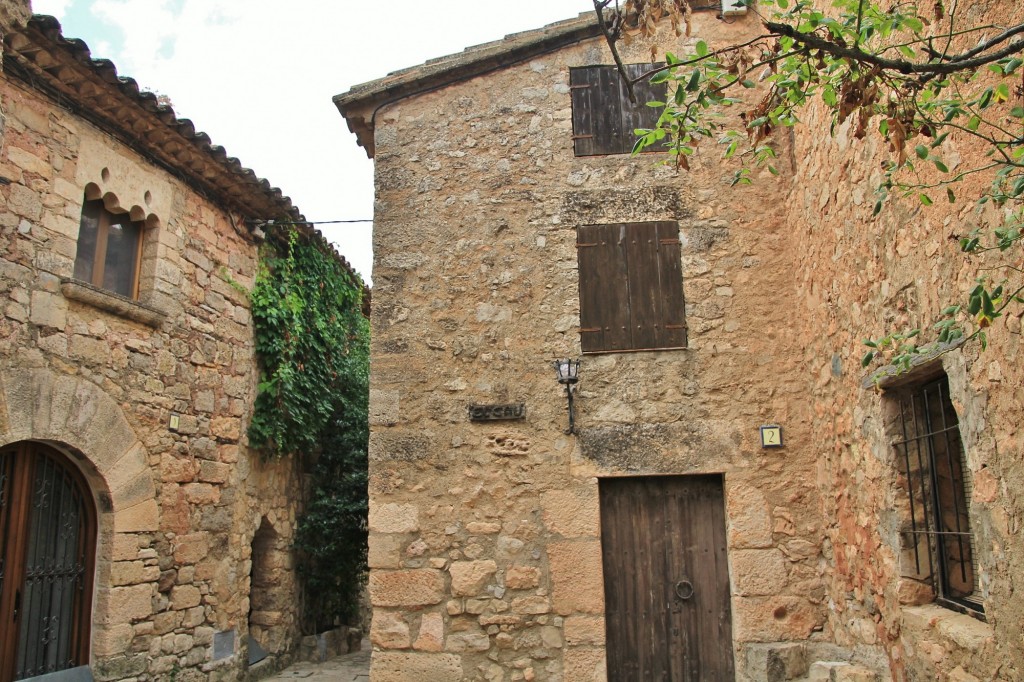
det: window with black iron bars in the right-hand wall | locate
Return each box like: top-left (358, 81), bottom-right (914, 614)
top-left (894, 375), bottom-right (984, 613)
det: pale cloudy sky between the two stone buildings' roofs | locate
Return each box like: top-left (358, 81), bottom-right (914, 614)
top-left (32, 0), bottom-right (593, 281)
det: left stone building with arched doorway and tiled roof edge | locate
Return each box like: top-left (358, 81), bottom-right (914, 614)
top-left (0, 2), bottom-right (327, 682)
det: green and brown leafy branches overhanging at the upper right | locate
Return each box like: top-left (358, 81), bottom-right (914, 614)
top-left (614, 0), bottom-right (1024, 364)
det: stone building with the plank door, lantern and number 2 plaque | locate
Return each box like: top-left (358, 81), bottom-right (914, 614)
top-left (335, 3), bottom-right (1024, 682)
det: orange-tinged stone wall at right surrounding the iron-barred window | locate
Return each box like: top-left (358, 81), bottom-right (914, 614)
top-left (787, 1), bottom-right (1024, 680)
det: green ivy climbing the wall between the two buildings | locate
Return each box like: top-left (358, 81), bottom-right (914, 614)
top-left (249, 225), bottom-right (370, 633)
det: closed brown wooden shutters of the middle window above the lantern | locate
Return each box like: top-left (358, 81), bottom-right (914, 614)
top-left (577, 221), bottom-right (686, 353)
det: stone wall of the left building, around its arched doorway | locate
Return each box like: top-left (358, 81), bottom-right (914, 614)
top-left (0, 62), bottom-right (301, 680)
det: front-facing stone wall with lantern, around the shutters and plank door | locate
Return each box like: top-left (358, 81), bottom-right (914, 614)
top-left (370, 12), bottom-right (827, 682)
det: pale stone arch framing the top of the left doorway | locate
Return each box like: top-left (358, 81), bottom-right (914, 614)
top-left (0, 369), bottom-right (160, 534)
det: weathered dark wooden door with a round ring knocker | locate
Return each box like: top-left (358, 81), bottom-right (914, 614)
top-left (600, 475), bottom-right (735, 682)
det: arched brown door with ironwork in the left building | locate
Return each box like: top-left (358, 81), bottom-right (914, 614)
top-left (0, 441), bottom-right (96, 682)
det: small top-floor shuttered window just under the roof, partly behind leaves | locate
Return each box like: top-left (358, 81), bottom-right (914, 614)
top-left (569, 63), bottom-right (668, 157)
